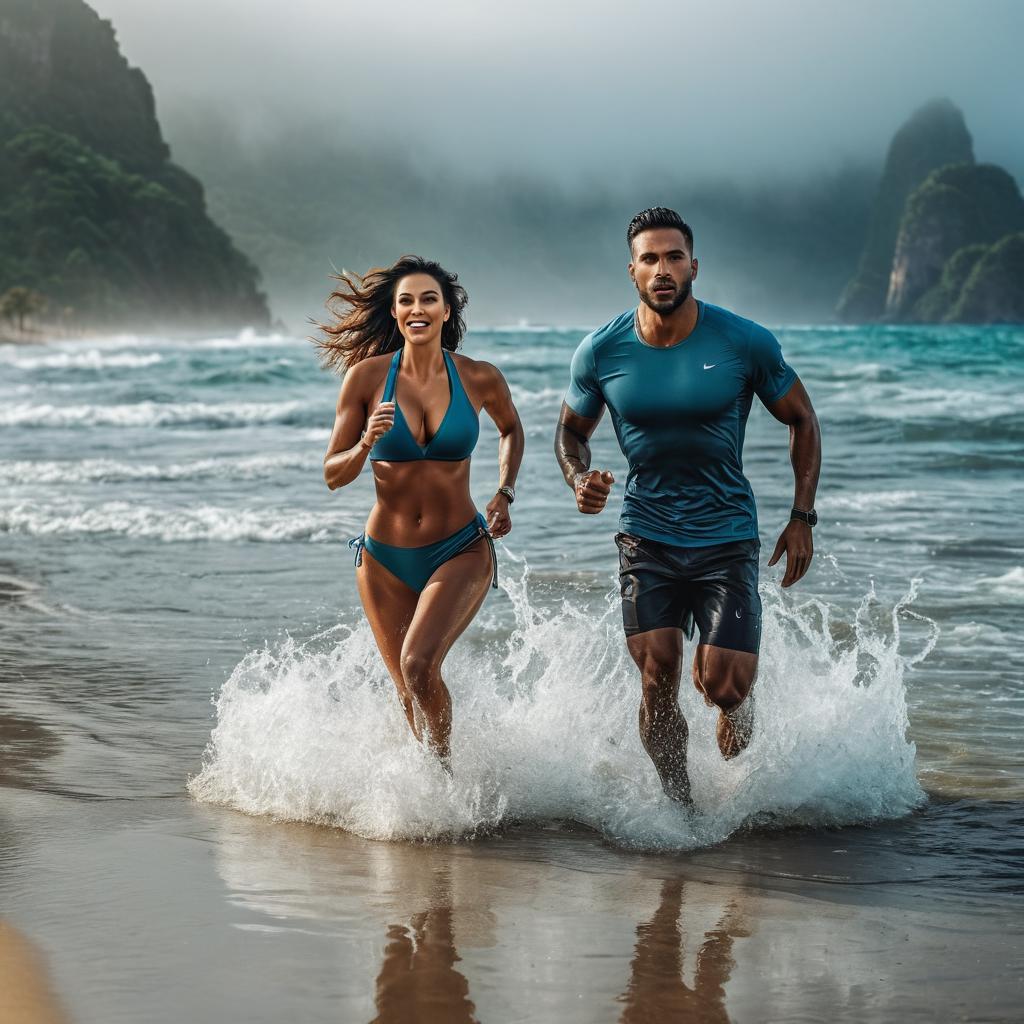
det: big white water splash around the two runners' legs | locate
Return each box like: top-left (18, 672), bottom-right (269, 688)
top-left (188, 574), bottom-right (938, 849)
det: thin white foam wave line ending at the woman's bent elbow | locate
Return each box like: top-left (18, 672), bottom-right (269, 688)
top-left (0, 455), bottom-right (322, 484)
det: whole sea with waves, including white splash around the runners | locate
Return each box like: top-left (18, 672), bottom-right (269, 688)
top-left (0, 327), bottom-right (1024, 827)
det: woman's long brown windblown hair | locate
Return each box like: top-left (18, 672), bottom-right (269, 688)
top-left (313, 256), bottom-right (469, 371)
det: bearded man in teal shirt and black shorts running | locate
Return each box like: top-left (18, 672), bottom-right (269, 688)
top-left (555, 207), bottom-right (821, 806)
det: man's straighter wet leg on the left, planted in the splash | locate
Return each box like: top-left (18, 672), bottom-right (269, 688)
top-left (626, 628), bottom-right (692, 806)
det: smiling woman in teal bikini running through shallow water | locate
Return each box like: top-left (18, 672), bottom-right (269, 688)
top-left (317, 256), bottom-right (523, 771)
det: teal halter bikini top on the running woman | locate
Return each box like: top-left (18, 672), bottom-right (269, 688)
top-left (370, 348), bottom-right (480, 462)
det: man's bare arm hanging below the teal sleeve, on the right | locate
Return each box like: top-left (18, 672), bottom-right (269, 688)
top-left (768, 379), bottom-right (821, 587)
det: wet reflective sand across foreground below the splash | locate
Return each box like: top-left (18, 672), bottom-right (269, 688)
top-left (0, 788), bottom-right (1024, 1022)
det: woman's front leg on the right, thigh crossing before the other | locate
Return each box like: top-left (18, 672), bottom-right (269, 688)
top-left (401, 538), bottom-right (492, 768)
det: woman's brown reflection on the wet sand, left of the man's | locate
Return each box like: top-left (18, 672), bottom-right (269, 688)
top-left (372, 871), bottom-right (476, 1024)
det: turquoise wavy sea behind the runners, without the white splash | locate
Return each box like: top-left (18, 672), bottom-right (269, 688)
top-left (0, 327), bottom-right (1024, 803)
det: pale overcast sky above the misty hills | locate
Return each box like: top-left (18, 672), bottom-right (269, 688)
top-left (88, 0), bottom-right (1024, 182)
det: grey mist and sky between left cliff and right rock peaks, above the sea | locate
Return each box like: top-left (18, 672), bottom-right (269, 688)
top-left (77, 0), bottom-right (1024, 327)
